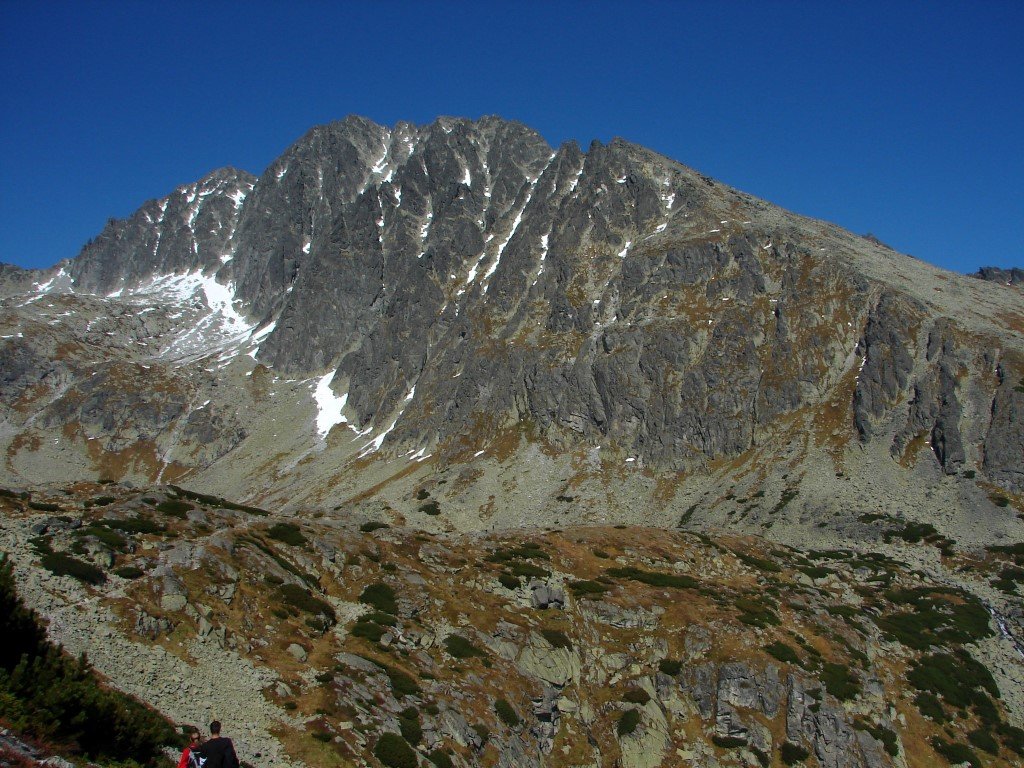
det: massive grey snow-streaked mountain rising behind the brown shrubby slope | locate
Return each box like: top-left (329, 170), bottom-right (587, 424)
top-left (0, 118), bottom-right (1024, 544)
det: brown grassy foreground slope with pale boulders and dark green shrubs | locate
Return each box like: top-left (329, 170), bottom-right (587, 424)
top-left (0, 484), bottom-right (1024, 768)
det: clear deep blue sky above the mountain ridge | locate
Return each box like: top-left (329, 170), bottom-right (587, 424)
top-left (0, 0), bottom-right (1024, 271)
